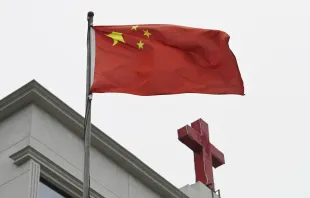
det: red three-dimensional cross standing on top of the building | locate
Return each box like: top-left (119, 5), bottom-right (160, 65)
top-left (178, 119), bottom-right (225, 190)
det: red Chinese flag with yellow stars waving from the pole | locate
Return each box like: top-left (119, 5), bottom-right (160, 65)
top-left (91, 25), bottom-right (244, 96)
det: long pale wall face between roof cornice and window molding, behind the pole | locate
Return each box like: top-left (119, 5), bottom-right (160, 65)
top-left (30, 105), bottom-right (159, 198)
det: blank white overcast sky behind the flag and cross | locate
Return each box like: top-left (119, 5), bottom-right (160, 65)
top-left (0, 0), bottom-right (310, 198)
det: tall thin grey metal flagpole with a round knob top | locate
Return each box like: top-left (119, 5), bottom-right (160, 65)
top-left (83, 11), bottom-right (94, 198)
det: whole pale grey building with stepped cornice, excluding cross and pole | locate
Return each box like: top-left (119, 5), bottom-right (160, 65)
top-left (0, 80), bottom-right (219, 198)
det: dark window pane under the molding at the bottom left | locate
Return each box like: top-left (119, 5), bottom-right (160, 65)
top-left (38, 178), bottom-right (71, 198)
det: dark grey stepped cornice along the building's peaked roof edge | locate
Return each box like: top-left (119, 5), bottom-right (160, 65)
top-left (0, 80), bottom-right (188, 198)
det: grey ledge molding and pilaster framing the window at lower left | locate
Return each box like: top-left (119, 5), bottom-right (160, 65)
top-left (10, 146), bottom-right (105, 198)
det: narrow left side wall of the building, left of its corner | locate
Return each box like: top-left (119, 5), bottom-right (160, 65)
top-left (0, 107), bottom-right (38, 198)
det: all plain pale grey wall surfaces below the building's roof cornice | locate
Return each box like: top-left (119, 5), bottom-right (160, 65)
top-left (0, 105), bottom-right (159, 198)
